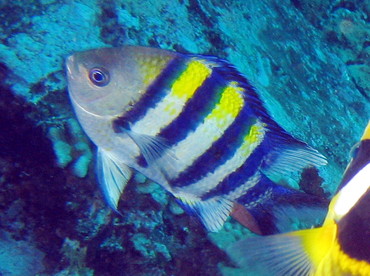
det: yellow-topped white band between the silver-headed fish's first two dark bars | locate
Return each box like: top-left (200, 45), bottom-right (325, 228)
top-left (132, 60), bottom-right (212, 136)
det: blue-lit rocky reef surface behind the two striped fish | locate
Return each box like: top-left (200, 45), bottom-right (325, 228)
top-left (0, 0), bottom-right (370, 276)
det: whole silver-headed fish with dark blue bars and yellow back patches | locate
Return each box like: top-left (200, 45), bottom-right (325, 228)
top-left (66, 46), bottom-right (327, 234)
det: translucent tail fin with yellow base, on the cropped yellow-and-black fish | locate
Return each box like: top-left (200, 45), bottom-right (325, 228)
top-left (227, 224), bottom-right (336, 276)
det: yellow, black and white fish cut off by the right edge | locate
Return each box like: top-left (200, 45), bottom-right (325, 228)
top-left (227, 121), bottom-right (370, 276)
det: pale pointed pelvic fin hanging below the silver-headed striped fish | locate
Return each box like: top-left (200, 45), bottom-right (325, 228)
top-left (96, 148), bottom-right (132, 212)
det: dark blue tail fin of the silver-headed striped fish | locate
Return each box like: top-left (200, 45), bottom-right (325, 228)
top-left (232, 175), bottom-right (329, 235)
